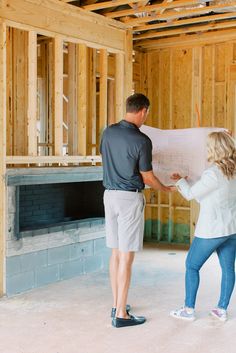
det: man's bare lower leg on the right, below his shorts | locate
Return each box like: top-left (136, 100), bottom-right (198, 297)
top-left (116, 251), bottom-right (135, 319)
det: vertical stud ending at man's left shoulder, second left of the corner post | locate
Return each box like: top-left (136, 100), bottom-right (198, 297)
top-left (98, 49), bottom-right (108, 142)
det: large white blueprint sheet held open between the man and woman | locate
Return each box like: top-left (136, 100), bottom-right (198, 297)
top-left (140, 125), bottom-right (226, 185)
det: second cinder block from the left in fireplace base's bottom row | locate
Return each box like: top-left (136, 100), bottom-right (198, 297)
top-left (35, 265), bottom-right (60, 287)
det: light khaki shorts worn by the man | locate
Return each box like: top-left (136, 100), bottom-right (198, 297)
top-left (104, 190), bottom-right (145, 252)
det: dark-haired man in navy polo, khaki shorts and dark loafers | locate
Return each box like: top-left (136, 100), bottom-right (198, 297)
top-left (100, 93), bottom-right (171, 327)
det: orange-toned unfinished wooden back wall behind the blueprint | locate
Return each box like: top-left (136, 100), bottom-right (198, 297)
top-left (134, 39), bottom-right (236, 242)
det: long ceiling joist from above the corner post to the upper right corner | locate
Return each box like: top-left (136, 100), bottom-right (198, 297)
top-left (124, 1), bottom-right (236, 26)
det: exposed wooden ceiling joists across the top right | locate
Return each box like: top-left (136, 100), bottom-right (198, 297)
top-left (57, 0), bottom-right (236, 49)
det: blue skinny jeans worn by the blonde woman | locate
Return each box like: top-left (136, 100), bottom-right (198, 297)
top-left (185, 234), bottom-right (236, 310)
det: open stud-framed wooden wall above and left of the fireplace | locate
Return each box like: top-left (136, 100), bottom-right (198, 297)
top-left (0, 0), bottom-right (132, 295)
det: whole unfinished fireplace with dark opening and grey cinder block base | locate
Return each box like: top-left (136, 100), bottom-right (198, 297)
top-left (6, 166), bottom-right (109, 295)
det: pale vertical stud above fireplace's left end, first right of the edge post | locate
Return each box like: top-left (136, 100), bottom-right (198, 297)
top-left (27, 31), bottom-right (37, 156)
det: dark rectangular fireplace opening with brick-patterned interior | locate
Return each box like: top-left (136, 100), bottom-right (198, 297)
top-left (18, 181), bottom-right (104, 232)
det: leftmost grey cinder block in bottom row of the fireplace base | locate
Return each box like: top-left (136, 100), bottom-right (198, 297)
top-left (6, 271), bottom-right (35, 295)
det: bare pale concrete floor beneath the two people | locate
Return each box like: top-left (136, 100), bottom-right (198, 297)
top-left (0, 245), bottom-right (236, 353)
